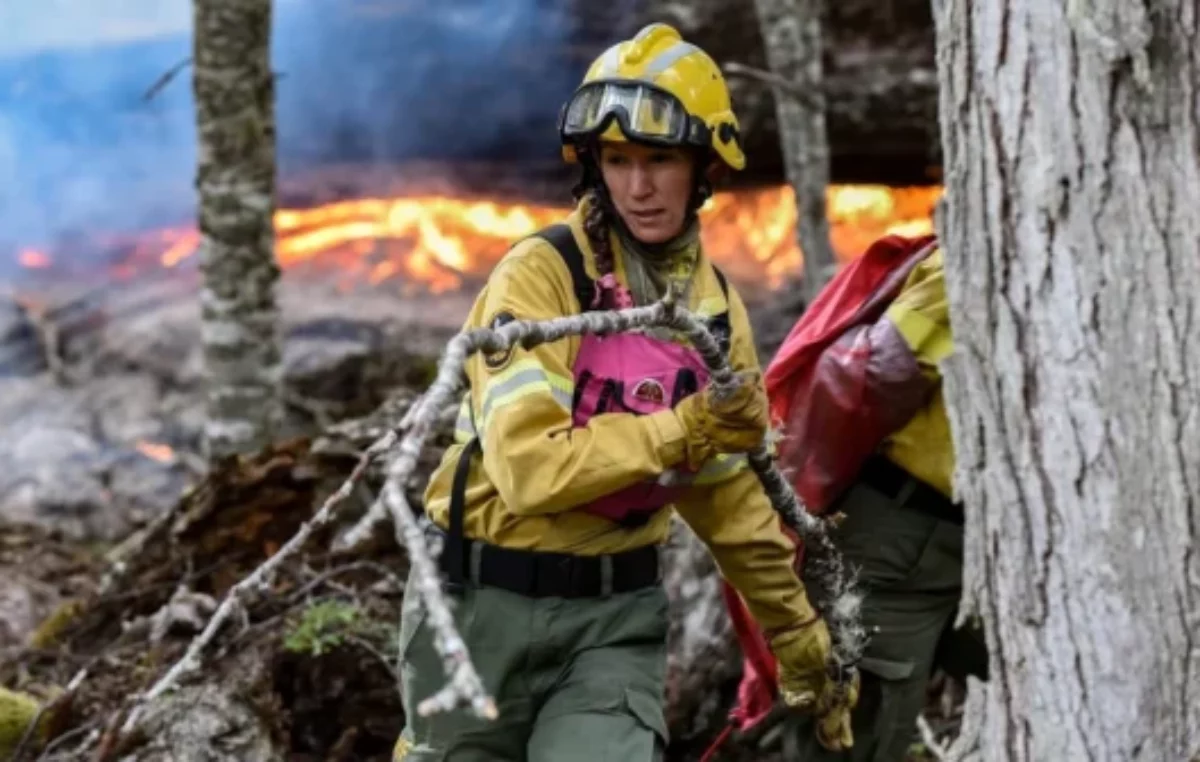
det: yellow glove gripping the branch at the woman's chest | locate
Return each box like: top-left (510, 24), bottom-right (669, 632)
top-left (674, 373), bottom-right (769, 468)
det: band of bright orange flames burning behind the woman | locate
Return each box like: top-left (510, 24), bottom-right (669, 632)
top-left (18, 185), bottom-right (941, 293)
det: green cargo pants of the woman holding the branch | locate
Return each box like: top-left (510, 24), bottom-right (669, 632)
top-left (395, 571), bottom-right (667, 762)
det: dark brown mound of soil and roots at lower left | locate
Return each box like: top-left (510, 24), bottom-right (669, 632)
top-left (0, 422), bottom-right (434, 761)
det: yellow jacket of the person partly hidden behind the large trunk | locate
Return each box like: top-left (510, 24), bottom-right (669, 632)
top-left (882, 248), bottom-right (954, 497)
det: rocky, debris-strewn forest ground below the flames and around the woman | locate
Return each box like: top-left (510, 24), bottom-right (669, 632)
top-left (0, 271), bottom-right (954, 761)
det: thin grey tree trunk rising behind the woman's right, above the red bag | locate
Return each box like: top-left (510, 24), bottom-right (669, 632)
top-left (755, 0), bottom-right (834, 305)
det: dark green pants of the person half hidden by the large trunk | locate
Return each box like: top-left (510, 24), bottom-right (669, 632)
top-left (797, 484), bottom-right (988, 762)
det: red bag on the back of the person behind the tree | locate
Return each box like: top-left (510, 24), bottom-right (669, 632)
top-left (702, 235), bottom-right (935, 762)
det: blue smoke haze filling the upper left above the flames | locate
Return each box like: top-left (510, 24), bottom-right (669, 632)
top-left (0, 0), bottom-right (599, 259)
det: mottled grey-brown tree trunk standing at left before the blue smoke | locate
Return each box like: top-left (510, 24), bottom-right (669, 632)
top-left (192, 0), bottom-right (282, 457)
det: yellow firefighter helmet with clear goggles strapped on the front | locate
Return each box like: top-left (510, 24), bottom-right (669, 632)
top-left (558, 23), bottom-right (746, 169)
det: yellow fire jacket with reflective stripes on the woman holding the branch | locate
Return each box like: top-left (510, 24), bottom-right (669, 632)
top-left (425, 199), bottom-right (809, 631)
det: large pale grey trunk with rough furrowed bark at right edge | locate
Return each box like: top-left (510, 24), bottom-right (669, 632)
top-left (934, 0), bottom-right (1200, 761)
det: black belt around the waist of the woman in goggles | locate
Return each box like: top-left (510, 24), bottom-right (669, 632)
top-left (438, 538), bottom-right (661, 598)
